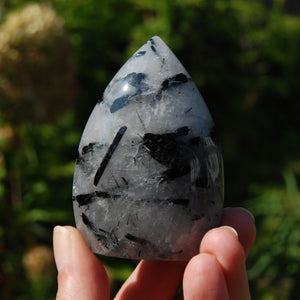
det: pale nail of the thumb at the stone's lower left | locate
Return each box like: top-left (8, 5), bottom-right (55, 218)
top-left (53, 226), bottom-right (71, 272)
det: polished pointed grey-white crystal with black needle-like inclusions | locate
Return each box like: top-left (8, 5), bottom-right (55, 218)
top-left (73, 37), bottom-right (223, 260)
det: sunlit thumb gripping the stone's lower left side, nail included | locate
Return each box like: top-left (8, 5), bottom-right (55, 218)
top-left (53, 226), bottom-right (109, 300)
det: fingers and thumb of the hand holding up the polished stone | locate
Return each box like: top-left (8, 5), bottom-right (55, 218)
top-left (53, 208), bottom-right (256, 300)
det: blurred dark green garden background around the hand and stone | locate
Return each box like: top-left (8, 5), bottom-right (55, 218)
top-left (0, 0), bottom-right (300, 300)
